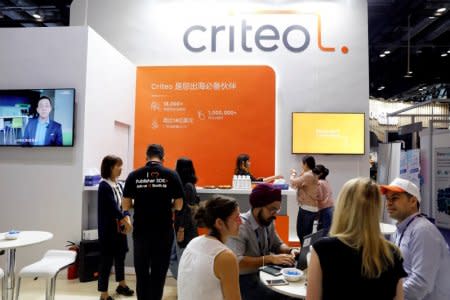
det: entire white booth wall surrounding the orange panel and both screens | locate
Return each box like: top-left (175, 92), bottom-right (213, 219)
top-left (0, 0), bottom-right (369, 267)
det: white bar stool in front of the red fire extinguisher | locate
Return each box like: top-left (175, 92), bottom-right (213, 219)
top-left (16, 250), bottom-right (77, 300)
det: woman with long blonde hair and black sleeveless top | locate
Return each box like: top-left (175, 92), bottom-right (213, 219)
top-left (307, 178), bottom-right (407, 300)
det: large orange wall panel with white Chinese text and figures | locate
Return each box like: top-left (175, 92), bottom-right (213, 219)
top-left (134, 66), bottom-right (275, 185)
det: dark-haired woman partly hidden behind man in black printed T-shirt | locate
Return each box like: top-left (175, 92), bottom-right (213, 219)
top-left (170, 157), bottom-right (200, 279)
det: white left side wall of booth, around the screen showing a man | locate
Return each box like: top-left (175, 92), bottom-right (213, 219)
top-left (0, 27), bottom-right (135, 268)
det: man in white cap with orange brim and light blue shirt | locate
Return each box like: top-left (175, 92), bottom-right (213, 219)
top-left (381, 178), bottom-right (450, 300)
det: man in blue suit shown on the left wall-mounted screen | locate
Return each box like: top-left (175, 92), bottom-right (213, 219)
top-left (23, 96), bottom-right (62, 146)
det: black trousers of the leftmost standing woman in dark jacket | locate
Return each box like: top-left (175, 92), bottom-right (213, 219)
top-left (98, 252), bottom-right (126, 292)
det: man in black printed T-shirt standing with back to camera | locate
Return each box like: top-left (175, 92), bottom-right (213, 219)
top-left (122, 144), bottom-right (183, 300)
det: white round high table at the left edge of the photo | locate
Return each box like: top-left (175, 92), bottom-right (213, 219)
top-left (0, 231), bottom-right (53, 300)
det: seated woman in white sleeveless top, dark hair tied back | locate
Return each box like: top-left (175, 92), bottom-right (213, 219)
top-left (178, 196), bottom-right (241, 300)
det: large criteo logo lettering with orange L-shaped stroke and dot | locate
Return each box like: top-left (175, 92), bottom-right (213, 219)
top-left (183, 17), bottom-right (348, 54)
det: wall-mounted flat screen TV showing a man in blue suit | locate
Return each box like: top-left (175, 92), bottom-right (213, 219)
top-left (0, 88), bottom-right (75, 147)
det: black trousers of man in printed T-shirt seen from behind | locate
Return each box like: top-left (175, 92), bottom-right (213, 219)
top-left (133, 227), bottom-right (174, 300)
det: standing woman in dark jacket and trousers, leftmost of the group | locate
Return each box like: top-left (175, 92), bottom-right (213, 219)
top-left (97, 155), bottom-right (134, 300)
